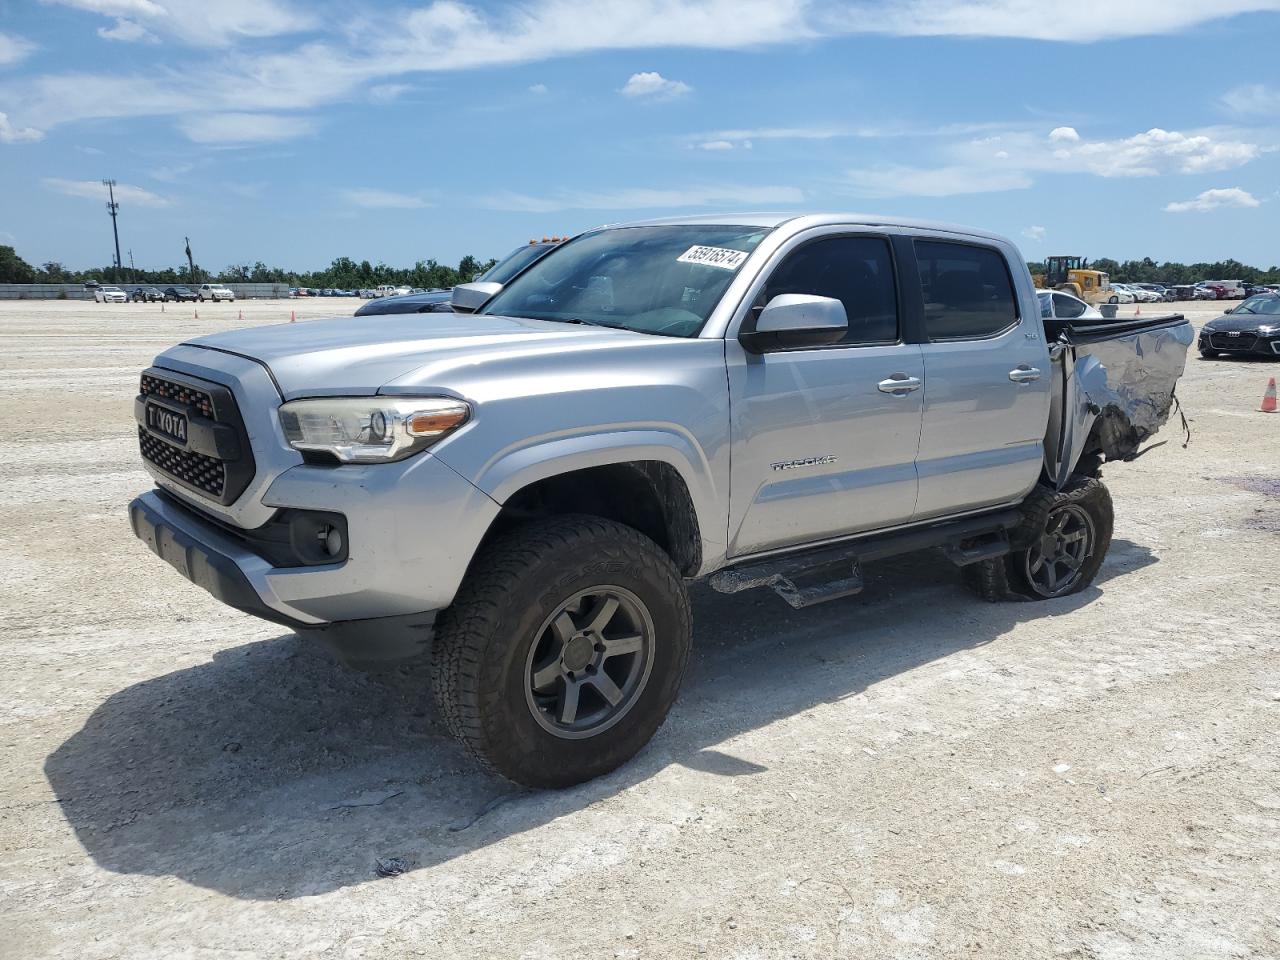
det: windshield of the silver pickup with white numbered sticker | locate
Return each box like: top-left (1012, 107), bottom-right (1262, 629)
top-left (480, 224), bottom-right (769, 337)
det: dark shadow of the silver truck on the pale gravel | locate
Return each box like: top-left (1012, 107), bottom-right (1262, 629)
top-left (45, 540), bottom-right (1156, 900)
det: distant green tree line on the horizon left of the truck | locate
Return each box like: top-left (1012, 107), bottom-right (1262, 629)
top-left (0, 246), bottom-right (497, 289)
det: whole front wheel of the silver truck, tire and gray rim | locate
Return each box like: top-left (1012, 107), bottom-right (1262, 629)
top-left (431, 516), bottom-right (691, 787)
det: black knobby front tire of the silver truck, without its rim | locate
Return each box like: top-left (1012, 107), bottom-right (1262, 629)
top-left (431, 516), bottom-right (692, 787)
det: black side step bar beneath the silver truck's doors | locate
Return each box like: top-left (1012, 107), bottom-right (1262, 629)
top-left (708, 509), bottom-right (1023, 609)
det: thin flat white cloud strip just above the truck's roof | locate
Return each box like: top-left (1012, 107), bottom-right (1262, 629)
top-left (480, 186), bottom-right (804, 214)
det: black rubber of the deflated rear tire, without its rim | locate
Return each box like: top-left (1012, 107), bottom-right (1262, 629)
top-left (964, 476), bottom-right (1115, 603)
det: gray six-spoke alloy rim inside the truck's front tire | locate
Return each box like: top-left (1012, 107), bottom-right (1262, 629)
top-left (525, 585), bottom-right (654, 740)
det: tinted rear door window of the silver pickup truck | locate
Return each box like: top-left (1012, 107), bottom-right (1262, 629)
top-left (915, 241), bottom-right (1018, 340)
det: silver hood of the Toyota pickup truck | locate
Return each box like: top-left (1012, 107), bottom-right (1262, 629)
top-left (186, 314), bottom-right (669, 399)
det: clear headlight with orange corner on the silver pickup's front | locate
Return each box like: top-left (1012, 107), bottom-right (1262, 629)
top-left (280, 397), bottom-right (471, 463)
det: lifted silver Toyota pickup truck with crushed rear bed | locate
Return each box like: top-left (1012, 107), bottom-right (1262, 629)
top-left (129, 215), bottom-right (1192, 787)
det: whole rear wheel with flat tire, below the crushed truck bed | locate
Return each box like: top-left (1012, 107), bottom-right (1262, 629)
top-left (965, 477), bottom-right (1115, 603)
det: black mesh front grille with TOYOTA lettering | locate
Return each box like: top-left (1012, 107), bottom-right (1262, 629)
top-left (134, 367), bottom-right (255, 506)
